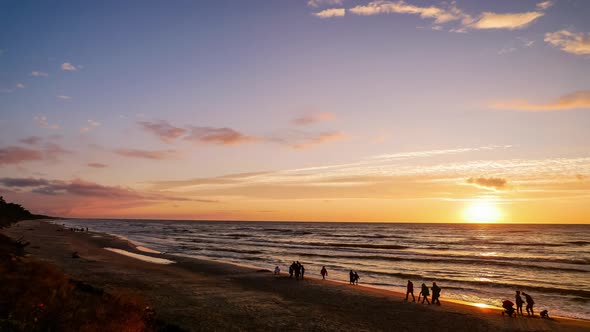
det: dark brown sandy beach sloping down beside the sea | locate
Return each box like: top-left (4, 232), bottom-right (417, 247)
top-left (2, 221), bottom-right (590, 331)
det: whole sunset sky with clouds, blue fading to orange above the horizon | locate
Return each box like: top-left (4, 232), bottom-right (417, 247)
top-left (0, 0), bottom-right (590, 224)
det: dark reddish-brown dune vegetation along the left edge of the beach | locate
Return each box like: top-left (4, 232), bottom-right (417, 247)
top-left (0, 197), bottom-right (181, 332)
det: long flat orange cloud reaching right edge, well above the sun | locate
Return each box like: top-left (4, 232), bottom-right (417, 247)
top-left (490, 90), bottom-right (590, 111)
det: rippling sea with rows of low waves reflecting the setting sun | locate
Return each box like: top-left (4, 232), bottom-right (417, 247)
top-left (56, 219), bottom-right (590, 320)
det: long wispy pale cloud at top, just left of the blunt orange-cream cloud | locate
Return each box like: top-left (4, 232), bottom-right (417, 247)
top-left (348, 1), bottom-right (470, 24)
